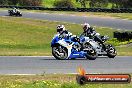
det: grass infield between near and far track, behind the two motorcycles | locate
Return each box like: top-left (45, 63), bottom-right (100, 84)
top-left (0, 17), bottom-right (132, 56)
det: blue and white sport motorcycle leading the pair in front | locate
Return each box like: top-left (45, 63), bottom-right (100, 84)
top-left (51, 34), bottom-right (97, 60)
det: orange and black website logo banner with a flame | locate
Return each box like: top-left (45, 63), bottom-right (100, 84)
top-left (76, 67), bottom-right (131, 84)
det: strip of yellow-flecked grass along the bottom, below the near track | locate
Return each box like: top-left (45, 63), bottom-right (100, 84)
top-left (0, 74), bottom-right (132, 88)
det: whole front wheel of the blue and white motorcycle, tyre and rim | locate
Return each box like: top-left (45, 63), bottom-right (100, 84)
top-left (52, 46), bottom-right (68, 60)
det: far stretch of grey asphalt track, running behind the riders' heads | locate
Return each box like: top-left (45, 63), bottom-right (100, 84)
top-left (0, 11), bottom-right (132, 30)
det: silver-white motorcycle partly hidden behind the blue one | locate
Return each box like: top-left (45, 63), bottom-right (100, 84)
top-left (80, 33), bottom-right (117, 58)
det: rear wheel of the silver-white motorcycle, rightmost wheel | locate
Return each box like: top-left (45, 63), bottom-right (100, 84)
top-left (107, 45), bottom-right (117, 58)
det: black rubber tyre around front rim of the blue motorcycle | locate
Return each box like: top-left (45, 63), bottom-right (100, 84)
top-left (52, 46), bottom-right (68, 60)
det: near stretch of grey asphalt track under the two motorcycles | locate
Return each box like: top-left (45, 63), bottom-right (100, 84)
top-left (0, 56), bottom-right (132, 74)
